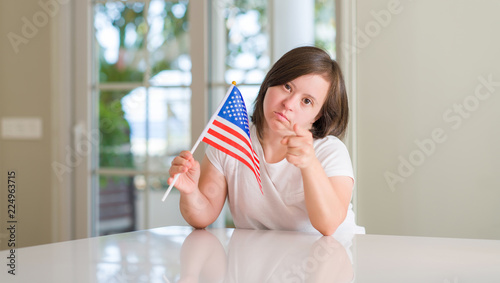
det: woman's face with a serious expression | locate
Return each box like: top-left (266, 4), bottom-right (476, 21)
top-left (263, 74), bottom-right (330, 136)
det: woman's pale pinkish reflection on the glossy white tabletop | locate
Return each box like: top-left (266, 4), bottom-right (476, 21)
top-left (178, 230), bottom-right (353, 282)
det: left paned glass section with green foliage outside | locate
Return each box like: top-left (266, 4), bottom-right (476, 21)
top-left (93, 0), bottom-right (191, 235)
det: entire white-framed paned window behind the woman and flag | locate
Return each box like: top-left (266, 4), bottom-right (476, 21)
top-left (91, 0), bottom-right (335, 235)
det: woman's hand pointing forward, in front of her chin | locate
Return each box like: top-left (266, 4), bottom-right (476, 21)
top-left (281, 124), bottom-right (316, 169)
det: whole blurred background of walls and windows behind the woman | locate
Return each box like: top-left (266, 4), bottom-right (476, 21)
top-left (0, 0), bottom-right (500, 249)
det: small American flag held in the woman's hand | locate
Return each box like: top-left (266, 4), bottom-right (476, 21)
top-left (202, 86), bottom-right (263, 193)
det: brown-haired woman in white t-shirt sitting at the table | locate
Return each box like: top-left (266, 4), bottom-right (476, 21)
top-left (168, 47), bottom-right (363, 235)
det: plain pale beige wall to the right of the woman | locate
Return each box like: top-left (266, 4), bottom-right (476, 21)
top-left (356, 0), bottom-right (500, 239)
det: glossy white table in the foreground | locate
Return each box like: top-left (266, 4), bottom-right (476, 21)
top-left (0, 227), bottom-right (500, 283)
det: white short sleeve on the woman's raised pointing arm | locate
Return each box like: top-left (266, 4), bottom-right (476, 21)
top-left (314, 136), bottom-right (354, 180)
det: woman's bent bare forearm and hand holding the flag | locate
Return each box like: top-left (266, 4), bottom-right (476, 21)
top-left (168, 152), bottom-right (227, 228)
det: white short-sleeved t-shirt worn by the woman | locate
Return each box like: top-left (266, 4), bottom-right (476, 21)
top-left (206, 125), bottom-right (364, 234)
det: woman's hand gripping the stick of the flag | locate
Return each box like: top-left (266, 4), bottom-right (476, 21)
top-left (167, 151), bottom-right (200, 194)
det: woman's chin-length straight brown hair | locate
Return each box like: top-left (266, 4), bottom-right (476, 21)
top-left (252, 46), bottom-right (349, 139)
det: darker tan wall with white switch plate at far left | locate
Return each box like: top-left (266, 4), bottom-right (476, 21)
top-left (0, 1), bottom-right (54, 250)
